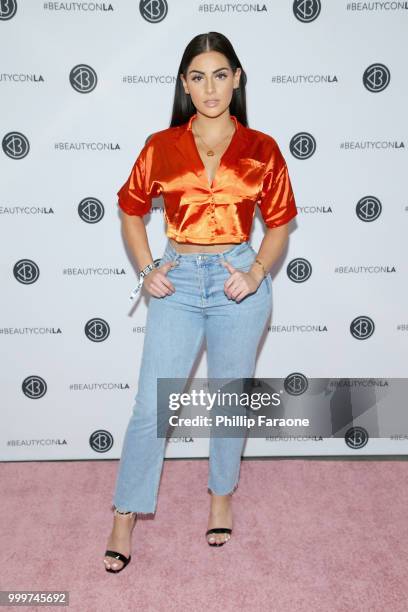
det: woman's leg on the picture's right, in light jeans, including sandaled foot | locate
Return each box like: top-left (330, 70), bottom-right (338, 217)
top-left (206, 262), bottom-right (272, 542)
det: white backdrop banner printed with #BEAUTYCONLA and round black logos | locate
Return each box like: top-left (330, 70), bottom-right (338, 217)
top-left (0, 0), bottom-right (408, 461)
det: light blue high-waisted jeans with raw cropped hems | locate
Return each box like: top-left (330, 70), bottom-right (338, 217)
top-left (113, 240), bottom-right (272, 513)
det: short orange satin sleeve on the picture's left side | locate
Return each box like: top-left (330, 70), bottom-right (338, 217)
top-left (117, 143), bottom-right (152, 217)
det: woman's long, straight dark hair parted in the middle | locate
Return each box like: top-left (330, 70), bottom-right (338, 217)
top-left (170, 32), bottom-right (248, 127)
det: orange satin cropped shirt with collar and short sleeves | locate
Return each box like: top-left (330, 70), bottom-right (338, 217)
top-left (118, 114), bottom-right (297, 244)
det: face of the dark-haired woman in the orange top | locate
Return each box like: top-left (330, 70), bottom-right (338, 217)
top-left (181, 51), bottom-right (241, 117)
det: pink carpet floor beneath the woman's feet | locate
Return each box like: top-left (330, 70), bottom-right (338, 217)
top-left (0, 458), bottom-right (408, 612)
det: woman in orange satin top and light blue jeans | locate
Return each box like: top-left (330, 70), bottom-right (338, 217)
top-left (104, 32), bottom-right (297, 573)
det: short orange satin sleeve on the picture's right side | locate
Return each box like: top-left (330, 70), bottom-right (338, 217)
top-left (259, 142), bottom-right (298, 228)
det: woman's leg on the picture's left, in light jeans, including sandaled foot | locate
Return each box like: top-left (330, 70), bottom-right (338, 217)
top-left (104, 292), bottom-right (204, 569)
